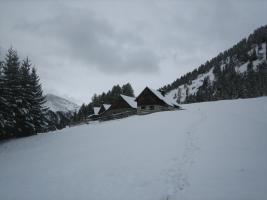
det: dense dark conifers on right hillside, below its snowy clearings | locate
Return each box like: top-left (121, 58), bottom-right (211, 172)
top-left (185, 62), bottom-right (267, 103)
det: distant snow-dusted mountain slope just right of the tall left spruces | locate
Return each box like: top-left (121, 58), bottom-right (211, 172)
top-left (45, 94), bottom-right (80, 112)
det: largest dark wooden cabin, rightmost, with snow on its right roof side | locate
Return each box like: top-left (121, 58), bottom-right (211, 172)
top-left (135, 87), bottom-right (179, 114)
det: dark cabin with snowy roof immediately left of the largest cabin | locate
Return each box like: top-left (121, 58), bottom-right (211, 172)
top-left (102, 95), bottom-right (137, 119)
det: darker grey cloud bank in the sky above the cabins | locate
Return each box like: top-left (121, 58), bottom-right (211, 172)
top-left (18, 7), bottom-right (160, 74)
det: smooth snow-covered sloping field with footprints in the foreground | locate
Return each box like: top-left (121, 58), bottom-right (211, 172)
top-left (0, 97), bottom-right (267, 200)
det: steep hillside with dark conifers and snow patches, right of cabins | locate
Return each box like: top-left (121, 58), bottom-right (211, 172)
top-left (160, 26), bottom-right (267, 103)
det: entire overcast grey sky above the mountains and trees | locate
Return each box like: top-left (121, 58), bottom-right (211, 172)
top-left (0, 0), bottom-right (267, 104)
